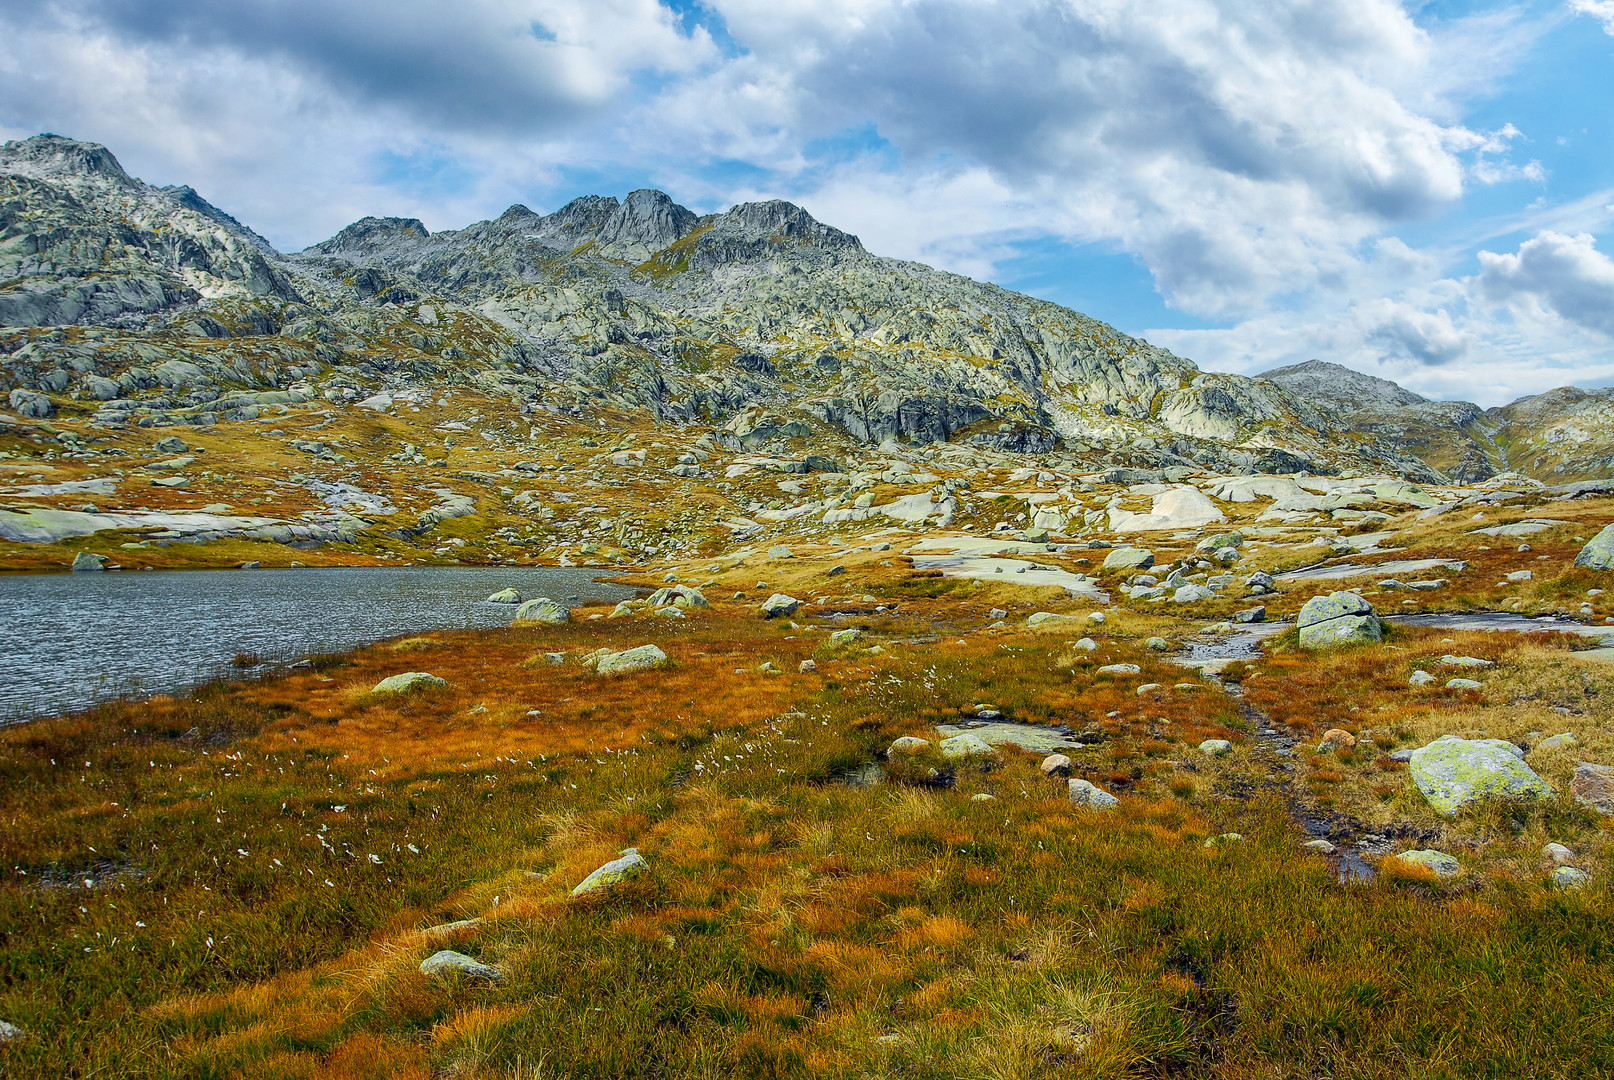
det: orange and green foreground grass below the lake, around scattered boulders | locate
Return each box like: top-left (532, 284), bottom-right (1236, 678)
top-left (0, 609), bottom-right (1614, 1077)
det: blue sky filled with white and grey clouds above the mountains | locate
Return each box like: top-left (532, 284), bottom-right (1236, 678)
top-left (0, 0), bottom-right (1614, 405)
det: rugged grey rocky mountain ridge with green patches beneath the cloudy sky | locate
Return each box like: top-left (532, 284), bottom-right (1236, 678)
top-left (0, 136), bottom-right (1603, 479)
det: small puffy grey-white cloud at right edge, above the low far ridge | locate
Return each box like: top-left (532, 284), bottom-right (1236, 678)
top-left (1480, 232), bottom-right (1614, 337)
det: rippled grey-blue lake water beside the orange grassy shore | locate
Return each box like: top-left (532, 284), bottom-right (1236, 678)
top-left (0, 567), bottom-right (634, 722)
